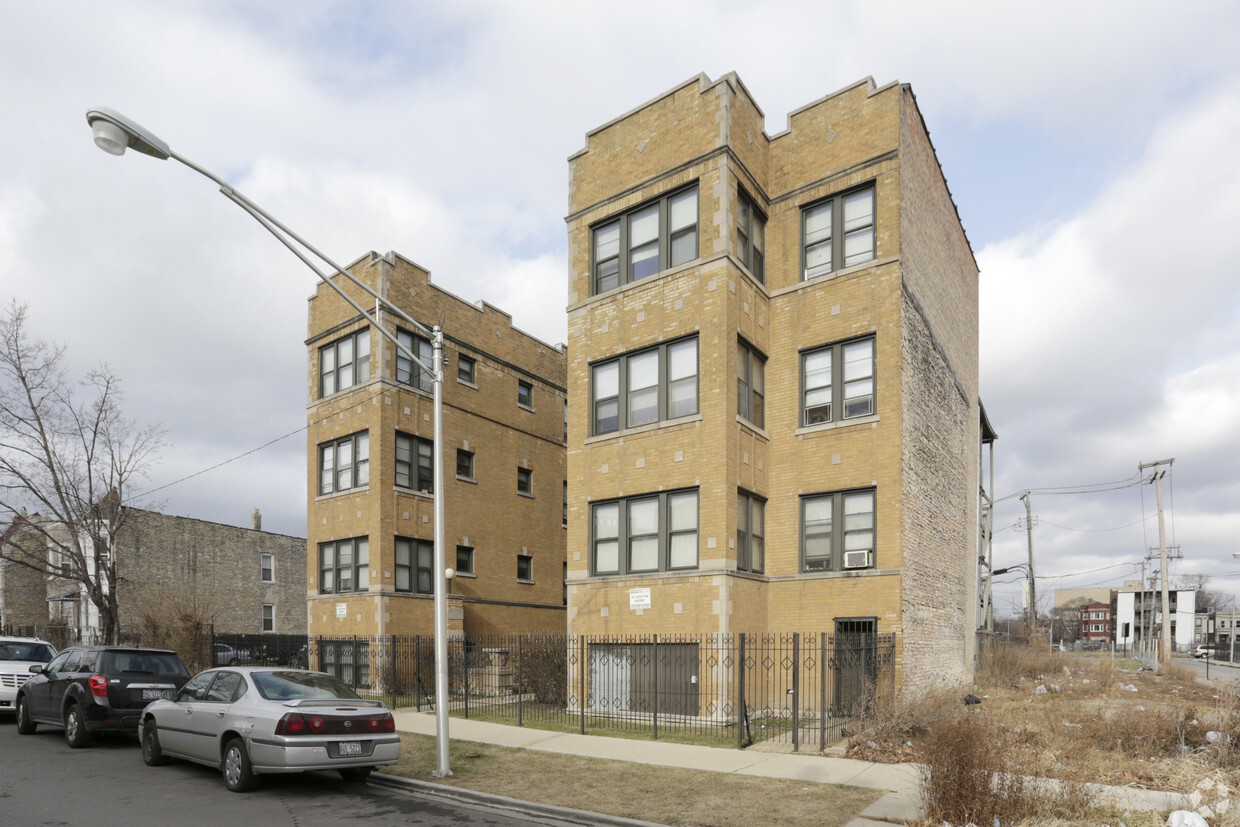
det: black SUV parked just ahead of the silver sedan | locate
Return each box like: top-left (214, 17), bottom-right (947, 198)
top-left (16, 646), bottom-right (190, 748)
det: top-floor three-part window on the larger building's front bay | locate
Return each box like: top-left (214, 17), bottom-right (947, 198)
top-left (590, 186), bottom-right (698, 294)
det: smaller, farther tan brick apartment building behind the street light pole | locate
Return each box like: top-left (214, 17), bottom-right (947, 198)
top-left (306, 253), bottom-right (567, 639)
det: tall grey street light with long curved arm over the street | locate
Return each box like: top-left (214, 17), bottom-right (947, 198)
top-left (86, 107), bottom-right (453, 777)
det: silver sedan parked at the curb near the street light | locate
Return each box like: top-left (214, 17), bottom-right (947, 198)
top-left (138, 666), bottom-right (401, 792)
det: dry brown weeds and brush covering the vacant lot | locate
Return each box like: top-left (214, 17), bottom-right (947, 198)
top-left (848, 647), bottom-right (1240, 827)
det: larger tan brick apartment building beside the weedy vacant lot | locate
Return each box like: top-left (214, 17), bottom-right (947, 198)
top-left (567, 74), bottom-right (980, 686)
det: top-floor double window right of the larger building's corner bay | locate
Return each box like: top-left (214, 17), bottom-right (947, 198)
top-left (801, 185), bottom-right (874, 279)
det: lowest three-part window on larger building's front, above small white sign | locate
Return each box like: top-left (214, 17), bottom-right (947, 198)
top-left (590, 490), bottom-right (698, 574)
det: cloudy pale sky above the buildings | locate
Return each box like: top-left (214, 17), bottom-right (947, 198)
top-left (0, 0), bottom-right (1240, 614)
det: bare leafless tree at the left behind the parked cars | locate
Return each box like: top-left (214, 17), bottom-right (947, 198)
top-left (0, 301), bottom-right (164, 642)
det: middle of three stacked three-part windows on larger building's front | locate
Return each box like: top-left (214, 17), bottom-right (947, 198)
top-left (590, 337), bottom-right (698, 435)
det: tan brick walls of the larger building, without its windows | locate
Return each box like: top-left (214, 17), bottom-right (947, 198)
top-left (567, 74), bottom-right (980, 687)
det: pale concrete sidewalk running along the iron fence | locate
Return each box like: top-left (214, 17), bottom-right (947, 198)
top-left (392, 709), bottom-right (1192, 827)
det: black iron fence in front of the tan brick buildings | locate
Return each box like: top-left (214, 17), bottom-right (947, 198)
top-left (286, 634), bottom-right (895, 750)
